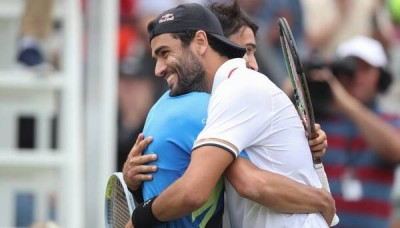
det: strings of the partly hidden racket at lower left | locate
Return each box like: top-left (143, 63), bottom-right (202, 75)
top-left (112, 181), bottom-right (131, 228)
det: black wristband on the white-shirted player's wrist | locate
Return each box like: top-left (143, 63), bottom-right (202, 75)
top-left (131, 196), bottom-right (163, 228)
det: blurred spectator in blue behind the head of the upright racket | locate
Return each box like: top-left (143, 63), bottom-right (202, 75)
top-left (239, 0), bottom-right (308, 93)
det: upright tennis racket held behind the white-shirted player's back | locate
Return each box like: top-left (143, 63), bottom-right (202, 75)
top-left (278, 17), bottom-right (339, 226)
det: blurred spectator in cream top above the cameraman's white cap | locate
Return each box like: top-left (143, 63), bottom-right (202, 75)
top-left (302, 0), bottom-right (391, 60)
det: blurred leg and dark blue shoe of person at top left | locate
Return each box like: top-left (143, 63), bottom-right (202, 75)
top-left (17, 0), bottom-right (53, 68)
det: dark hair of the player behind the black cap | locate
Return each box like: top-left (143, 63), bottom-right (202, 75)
top-left (209, 0), bottom-right (258, 37)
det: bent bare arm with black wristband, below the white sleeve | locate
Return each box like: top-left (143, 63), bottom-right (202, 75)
top-left (132, 146), bottom-right (234, 227)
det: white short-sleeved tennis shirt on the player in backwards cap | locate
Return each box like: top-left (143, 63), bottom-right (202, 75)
top-left (194, 59), bottom-right (328, 228)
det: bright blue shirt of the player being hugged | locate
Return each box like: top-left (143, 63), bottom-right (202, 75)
top-left (143, 91), bottom-right (223, 227)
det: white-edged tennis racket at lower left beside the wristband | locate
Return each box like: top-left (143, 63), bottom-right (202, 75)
top-left (104, 172), bottom-right (135, 228)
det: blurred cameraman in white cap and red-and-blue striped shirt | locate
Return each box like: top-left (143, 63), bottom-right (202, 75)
top-left (308, 36), bottom-right (400, 227)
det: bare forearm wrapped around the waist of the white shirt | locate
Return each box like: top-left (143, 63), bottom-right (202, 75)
top-left (225, 157), bottom-right (336, 224)
